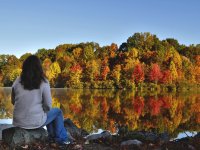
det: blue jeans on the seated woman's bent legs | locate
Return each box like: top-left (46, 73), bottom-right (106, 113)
top-left (43, 108), bottom-right (68, 143)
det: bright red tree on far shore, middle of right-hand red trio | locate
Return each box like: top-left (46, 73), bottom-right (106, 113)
top-left (149, 64), bottom-right (162, 82)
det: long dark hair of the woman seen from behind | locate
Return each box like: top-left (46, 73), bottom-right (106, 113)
top-left (21, 55), bottom-right (46, 90)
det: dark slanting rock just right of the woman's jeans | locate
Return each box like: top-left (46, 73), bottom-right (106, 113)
top-left (64, 118), bottom-right (89, 139)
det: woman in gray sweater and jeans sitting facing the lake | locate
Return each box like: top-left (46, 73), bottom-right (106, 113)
top-left (11, 55), bottom-right (70, 144)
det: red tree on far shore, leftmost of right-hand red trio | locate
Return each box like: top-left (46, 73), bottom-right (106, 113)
top-left (132, 64), bottom-right (144, 83)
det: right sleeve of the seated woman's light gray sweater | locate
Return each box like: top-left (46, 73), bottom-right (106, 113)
top-left (42, 83), bottom-right (52, 112)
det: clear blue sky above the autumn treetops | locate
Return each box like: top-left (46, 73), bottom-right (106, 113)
top-left (0, 0), bottom-right (200, 57)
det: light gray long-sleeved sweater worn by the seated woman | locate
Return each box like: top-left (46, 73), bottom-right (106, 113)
top-left (12, 77), bottom-right (52, 129)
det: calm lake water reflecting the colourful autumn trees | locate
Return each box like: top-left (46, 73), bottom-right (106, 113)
top-left (0, 88), bottom-right (200, 138)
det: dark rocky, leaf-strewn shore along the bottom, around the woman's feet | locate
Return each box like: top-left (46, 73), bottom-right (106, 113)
top-left (0, 119), bottom-right (200, 150)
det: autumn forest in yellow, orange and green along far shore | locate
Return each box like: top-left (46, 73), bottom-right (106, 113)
top-left (0, 32), bottom-right (200, 91)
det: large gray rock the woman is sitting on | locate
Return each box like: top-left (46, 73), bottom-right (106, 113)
top-left (2, 127), bottom-right (47, 147)
